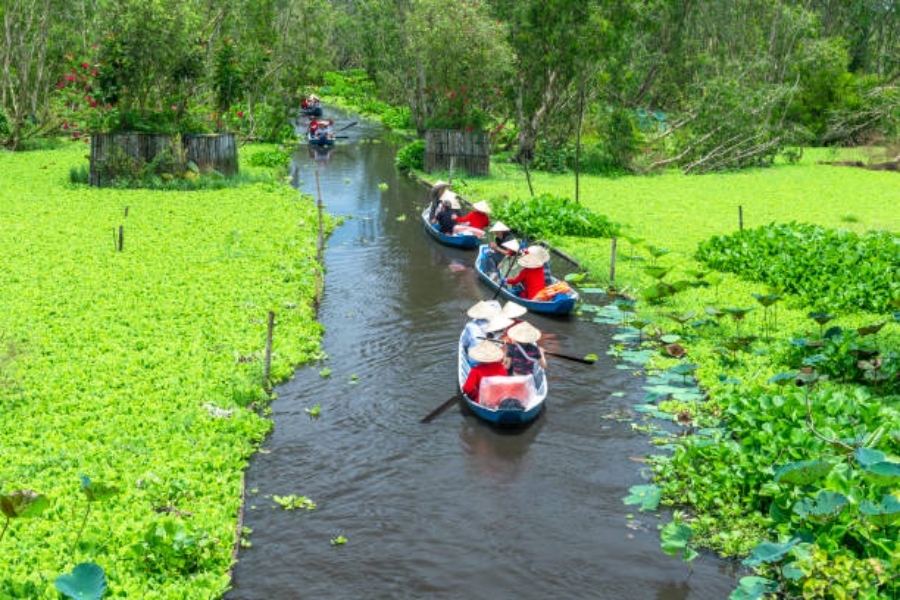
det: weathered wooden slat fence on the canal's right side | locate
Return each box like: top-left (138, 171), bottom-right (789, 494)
top-left (425, 129), bottom-right (491, 176)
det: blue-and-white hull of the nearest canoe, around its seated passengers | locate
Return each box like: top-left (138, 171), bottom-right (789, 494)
top-left (458, 335), bottom-right (547, 427)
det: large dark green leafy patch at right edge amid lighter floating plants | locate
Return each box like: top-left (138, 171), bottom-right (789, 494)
top-left (696, 223), bottom-right (900, 312)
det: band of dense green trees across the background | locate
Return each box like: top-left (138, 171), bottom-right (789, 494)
top-left (0, 0), bottom-right (900, 173)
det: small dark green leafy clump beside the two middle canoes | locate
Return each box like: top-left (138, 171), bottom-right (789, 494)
top-left (494, 194), bottom-right (619, 239)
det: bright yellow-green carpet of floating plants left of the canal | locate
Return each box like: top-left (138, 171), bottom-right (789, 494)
top-left (0, 146), bottom-right (330, 600)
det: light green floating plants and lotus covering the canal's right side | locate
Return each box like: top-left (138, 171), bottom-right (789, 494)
top-left (428, 155), bottom-right (900, 590)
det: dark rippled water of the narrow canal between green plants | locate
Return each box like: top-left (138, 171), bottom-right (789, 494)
top-left (226, 119), bottom-right (736, 600)
